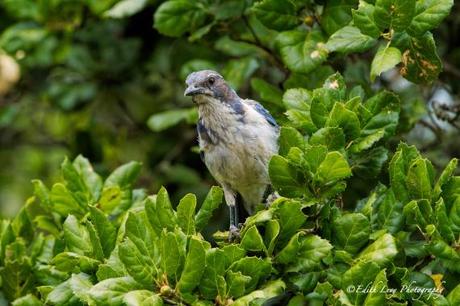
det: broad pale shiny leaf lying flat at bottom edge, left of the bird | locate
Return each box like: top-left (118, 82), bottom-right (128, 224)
top-left (88, 276), bottom-right (142, 305)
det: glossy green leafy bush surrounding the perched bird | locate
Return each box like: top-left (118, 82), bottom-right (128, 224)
top-left (0, 0), bottom-right (460, 306)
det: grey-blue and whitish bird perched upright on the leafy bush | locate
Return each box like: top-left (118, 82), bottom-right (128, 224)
top-left (184, 70), bottom-right (279, 238)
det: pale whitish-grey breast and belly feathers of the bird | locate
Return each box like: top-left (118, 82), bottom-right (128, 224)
top-left (197, 100), bottom-right (278, 191)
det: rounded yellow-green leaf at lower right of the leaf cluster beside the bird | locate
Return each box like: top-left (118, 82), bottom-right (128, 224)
top-left (314, 151), bottom-right (351, 186)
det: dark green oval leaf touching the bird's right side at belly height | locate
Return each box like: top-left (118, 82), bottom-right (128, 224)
top-left (268, 155), bottom-right (305, 197)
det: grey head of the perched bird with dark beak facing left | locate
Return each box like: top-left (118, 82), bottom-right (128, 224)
top-left (184, 70), bottom-right (238, 103)
